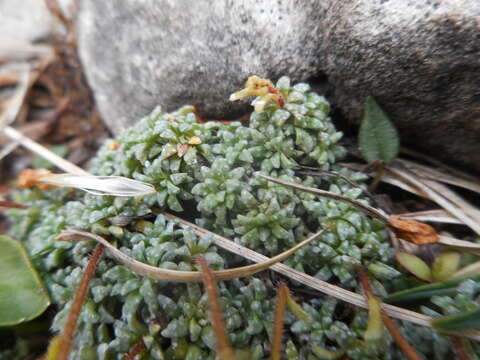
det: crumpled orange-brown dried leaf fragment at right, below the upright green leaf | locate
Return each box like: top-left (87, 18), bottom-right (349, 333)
top-left (388, 215), bottom-right (440, 245)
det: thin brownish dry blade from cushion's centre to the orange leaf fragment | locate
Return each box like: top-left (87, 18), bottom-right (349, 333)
top-left (254, 172), bottom-right (389, 224)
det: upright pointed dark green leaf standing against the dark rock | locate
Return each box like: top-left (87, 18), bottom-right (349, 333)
top-left (358, 97), bottom-right (400, 164)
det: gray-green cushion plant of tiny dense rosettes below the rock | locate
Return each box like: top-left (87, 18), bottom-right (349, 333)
top-left (1, 77), bottom-right (475, 360)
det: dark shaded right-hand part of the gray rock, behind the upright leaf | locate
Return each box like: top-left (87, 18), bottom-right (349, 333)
top-left (321, 0), bottom-right (480, 171)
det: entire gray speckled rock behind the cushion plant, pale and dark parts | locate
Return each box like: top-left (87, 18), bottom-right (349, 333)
top-left (78, 0), bottom-right (480, 170)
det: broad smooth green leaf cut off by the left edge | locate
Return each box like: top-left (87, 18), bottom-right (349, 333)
top-left (0, 236), bottom-right (50, 326)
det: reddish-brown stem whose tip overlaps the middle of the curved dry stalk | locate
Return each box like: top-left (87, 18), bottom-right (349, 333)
top-left (196, 255), bottom-right (236, 360)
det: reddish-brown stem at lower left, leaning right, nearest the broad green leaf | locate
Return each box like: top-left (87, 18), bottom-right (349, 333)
top-left (57, 244), bottom-right (104, 360)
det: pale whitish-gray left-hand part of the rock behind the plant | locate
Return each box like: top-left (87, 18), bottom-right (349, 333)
top-left (78, 0), bottom-right (321, 132)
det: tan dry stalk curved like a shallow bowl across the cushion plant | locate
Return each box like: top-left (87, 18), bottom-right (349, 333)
top-left (58, 229), bottom-right (324, 283)
